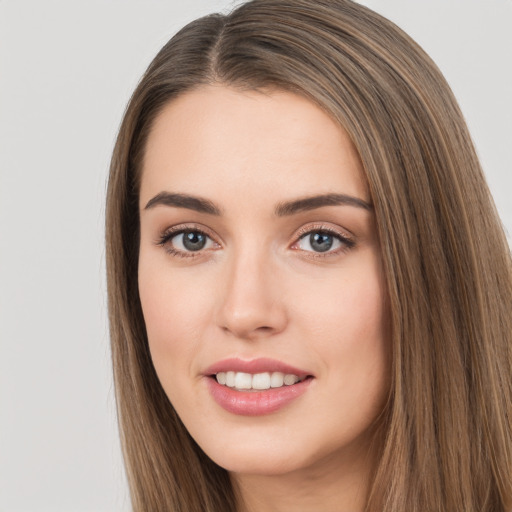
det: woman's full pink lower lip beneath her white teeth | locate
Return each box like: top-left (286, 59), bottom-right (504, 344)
top-left (207, 377), bottom-right (313, 416)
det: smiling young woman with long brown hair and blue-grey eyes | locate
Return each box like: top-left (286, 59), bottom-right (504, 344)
top-left (107, 0), bottom-right (512, 512)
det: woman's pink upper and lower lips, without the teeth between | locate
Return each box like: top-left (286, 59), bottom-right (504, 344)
top-left (204, 358), bottom-right (313, 416)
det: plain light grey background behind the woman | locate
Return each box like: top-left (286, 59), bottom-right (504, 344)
top-left (0, 0), bottom-right (512, 512)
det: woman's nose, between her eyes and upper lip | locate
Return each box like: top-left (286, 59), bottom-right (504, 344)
top-left (217, 248), bottom-right (288, 340)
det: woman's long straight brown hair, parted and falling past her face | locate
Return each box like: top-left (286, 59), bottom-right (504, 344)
top-left (106, 0), bottom-right (512, 512)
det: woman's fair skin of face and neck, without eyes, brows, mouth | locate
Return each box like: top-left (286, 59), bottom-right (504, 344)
top-left (139, 85), bottom-right (390, 512)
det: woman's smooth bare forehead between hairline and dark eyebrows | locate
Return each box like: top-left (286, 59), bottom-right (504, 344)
top-left (140, 86), bottom-right (369, 208)
